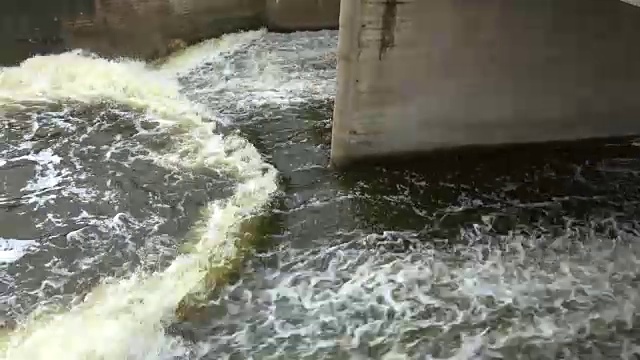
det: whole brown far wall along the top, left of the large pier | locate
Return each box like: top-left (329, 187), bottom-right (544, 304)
top-left (0, 0), bottom-right (340, 64)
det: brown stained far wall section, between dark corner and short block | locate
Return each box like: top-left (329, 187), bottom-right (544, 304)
top-left (63, 0), bottom-right (264, 59)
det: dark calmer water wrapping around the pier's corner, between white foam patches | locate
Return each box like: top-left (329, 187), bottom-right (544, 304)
top-left (230, 94), bottom-right (640, 252)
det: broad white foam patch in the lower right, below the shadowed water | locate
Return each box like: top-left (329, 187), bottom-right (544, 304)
top-left (195, 232), bottom-right (640, 359)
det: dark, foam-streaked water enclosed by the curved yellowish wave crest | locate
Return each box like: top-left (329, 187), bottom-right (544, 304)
top-left (0, 104), bottom-right (233, 317)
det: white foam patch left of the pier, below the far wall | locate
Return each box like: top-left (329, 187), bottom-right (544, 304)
top-left (172, 32), bottom-right (336, 109)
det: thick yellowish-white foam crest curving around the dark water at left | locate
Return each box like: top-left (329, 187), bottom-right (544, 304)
top-left (0, 32), bottom-right (277, 360)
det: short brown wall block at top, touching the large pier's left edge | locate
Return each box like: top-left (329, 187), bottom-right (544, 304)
top-left (266, 0), bottom-right (346, 31)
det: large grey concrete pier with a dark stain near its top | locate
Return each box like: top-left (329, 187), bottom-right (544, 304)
top-left (331, 0), bottom-right (640, 166)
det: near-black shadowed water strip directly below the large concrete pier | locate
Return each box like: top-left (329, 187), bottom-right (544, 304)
top-left (339, 139), bottom-right (640, 239)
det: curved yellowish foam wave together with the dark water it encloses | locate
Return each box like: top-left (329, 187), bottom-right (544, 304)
top-left (0, 28), bottom-right (277, 359)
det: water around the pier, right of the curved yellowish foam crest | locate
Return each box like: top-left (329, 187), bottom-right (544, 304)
top-left (152, 32), bottom-right (639, 359)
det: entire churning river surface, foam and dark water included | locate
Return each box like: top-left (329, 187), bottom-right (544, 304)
top-left (0, 31), bottom-right (640, 360)
